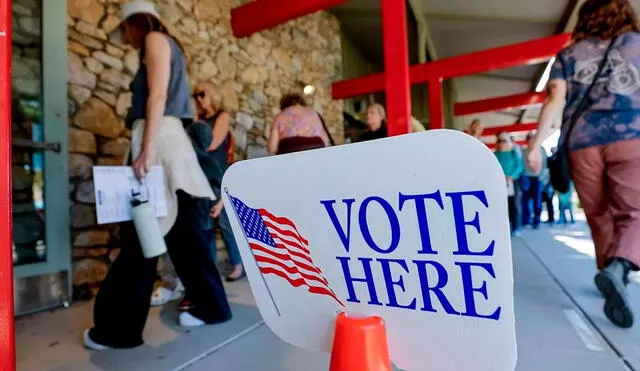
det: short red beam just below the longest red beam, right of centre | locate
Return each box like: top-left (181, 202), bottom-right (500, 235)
top-left (453, 93), bottom-right (547, 116)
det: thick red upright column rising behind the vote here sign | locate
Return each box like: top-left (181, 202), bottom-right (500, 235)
top-left (382, 0), bottom-right (411, 136)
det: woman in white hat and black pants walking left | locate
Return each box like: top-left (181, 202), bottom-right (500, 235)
top-left (84, 0), bottom-right (231, 350)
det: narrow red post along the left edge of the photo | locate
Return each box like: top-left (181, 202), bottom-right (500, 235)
top-left (0, 0), bottom-right (16, 371)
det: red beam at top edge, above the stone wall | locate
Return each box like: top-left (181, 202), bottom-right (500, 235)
top-left (231, 0), bottom-right (348, 38)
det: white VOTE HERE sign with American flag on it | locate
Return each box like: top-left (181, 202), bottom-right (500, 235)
top-left (223, 130), bottom-right (516, 371)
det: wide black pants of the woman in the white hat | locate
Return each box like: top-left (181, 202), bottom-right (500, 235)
top-left (90, 191), bottom-right (231, 348)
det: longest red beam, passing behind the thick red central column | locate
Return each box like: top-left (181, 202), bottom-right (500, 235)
top-left (331, 34), bottom-right (571, 99)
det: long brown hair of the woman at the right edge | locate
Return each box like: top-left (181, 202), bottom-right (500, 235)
top-left (573, 0), bottom-right (640, 42)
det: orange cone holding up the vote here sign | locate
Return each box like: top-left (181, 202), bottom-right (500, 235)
top-left (329, 313), bottom-right (391, 371)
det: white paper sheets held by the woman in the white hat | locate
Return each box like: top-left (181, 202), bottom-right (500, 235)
top-left (93, 166), bottom-right (167, 224)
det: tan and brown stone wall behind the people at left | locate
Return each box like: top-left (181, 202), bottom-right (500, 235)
top-left (68, 0), bottom-right (343, 284)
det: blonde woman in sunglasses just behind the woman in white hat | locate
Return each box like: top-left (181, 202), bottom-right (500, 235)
top-left (187, 81), bottom-right (244, 282)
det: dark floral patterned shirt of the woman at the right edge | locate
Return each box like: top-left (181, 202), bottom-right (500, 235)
top-left (551, 32), bottom-right (640, 150)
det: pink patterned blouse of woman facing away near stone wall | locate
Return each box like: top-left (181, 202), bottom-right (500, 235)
top-left (273, 106), bottom-right (329, 145)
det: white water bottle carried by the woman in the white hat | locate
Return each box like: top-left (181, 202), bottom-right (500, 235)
top-left (131, 193), bottom-right (167, 259)
